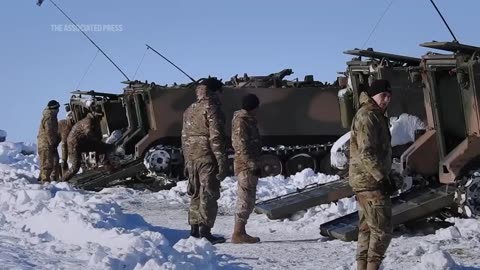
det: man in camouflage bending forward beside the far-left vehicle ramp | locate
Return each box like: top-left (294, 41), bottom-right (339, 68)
top-left (63, 111), bottom-right (113, 181)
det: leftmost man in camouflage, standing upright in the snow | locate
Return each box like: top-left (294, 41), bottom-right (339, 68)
top-left (37, 100), bottom-right (60, 182)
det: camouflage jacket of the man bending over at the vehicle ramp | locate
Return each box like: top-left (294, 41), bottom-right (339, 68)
top-left (67, 113), bottom-right (102, 149)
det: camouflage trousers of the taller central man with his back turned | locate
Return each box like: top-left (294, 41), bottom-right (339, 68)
top-left (185, 160), bottom-right (220, 228)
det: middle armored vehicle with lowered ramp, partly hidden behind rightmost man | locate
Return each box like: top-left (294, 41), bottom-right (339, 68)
top-left (255, 49), bottom-right (426, 219)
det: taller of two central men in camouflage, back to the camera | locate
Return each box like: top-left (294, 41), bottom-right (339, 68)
top-left (182, 78), bottom-right (227, 244)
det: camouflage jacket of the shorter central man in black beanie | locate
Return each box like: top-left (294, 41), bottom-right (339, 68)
top-left (232, 110), bottom-right (262, 175)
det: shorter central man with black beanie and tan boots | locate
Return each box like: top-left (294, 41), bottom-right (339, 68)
top-left (232, 94), bottom-right (262, 244)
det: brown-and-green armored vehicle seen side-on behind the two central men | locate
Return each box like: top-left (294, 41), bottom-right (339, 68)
top-left (70, 69), bottom-right (347, 188)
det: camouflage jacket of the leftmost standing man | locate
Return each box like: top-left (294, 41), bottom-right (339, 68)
top-left (37, 109), bottom-right (60, 148)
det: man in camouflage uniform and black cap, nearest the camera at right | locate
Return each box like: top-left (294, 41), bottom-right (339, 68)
top-left (349, 80), bottom-right (395, 270)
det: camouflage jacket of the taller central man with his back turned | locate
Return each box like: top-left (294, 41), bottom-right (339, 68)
top-left (182, 94), bottom-right (226, 164)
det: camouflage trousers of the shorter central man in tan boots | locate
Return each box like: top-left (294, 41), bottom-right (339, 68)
top-left (235, 170), bottom-right (258, 224)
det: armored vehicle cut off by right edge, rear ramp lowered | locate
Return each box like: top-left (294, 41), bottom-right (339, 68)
top-left (320, 42), bottom-right (480, 241)
